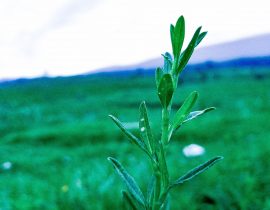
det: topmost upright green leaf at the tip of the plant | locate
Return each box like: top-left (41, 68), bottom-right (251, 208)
top-left (173, 16), bottom-right (185, 60)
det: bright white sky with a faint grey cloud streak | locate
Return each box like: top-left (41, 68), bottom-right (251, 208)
top-left (0, 0), bottom-right (270, 79)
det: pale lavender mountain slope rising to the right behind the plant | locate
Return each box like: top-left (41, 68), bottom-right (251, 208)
top-left (98, 34), bottom-right (270, 71)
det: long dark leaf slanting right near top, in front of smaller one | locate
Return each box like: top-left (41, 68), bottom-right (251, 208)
top-left (176, 27), bottom-right (202, 75)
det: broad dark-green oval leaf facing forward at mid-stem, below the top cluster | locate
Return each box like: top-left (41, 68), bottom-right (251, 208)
top-left (158, 74), bottom-right (174, 108)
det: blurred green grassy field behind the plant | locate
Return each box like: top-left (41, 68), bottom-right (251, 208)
top-left (0, 69), bottom-right (270, 210)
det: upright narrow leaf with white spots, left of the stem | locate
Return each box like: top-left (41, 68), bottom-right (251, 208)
top-left (139, 101), bottom-right (154, 154)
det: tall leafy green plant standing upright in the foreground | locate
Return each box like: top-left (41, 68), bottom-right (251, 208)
top-left (108, 16), bottom-right (222, 210)
